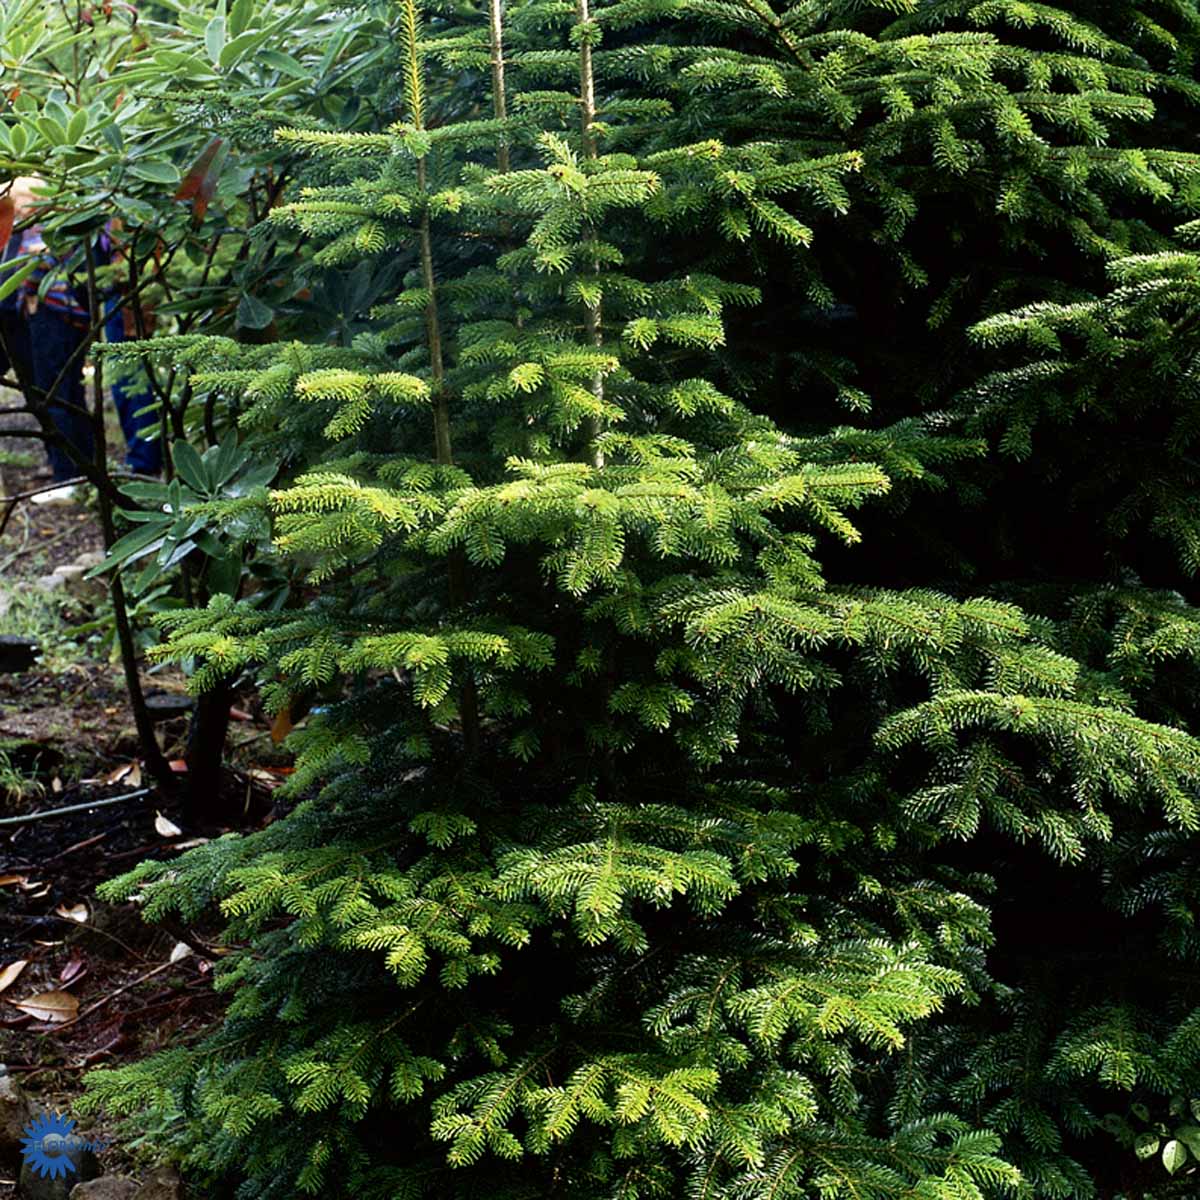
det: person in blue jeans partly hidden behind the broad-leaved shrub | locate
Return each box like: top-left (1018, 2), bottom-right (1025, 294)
top-left (0, 178), bottom-right (162, 499)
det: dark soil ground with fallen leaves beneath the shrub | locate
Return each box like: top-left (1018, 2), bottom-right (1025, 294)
top-left (0, 403), bottom-right (282, 1198)
